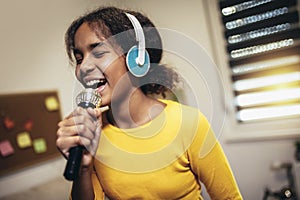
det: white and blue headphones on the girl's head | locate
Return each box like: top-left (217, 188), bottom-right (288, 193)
top-left (125, 13), bottom-right (150, 77)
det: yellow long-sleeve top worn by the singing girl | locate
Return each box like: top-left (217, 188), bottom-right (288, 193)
top-left (88, 100), bottom-right (242, 200)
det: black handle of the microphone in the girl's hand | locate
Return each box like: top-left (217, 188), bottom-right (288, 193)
top-left (64, 102), bottom-right (96, 181)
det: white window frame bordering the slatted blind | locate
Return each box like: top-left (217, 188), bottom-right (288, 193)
top-left (203, 0), bottom-right (300, 142)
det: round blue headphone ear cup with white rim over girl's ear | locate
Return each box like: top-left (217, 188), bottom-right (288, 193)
top-left (126, 46), bottom-right (150, 77)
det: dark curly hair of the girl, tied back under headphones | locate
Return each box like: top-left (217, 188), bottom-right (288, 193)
top-left (65, 7), bottom-right (179, 97)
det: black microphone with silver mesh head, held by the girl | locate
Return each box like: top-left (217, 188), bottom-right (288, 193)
top-left (64, 88), bottom-right (101, 181)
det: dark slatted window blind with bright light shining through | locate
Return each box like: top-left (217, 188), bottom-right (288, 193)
top-left (219, 0), bottom-right (300, 123)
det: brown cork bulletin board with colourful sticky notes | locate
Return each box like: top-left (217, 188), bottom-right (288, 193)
top-left (0, 91), bottom-right (61, 176)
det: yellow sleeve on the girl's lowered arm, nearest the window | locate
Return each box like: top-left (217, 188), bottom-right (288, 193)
top-left (188, 114), bottom-right (242, 200)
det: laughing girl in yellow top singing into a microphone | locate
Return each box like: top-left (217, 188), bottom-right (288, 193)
top-left (57, 7), bottom-right (242, 200)
